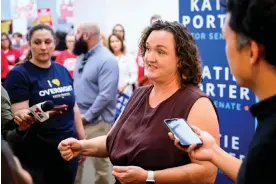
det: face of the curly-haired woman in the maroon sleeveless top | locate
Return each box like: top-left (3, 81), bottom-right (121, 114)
top-left (144, 30), bottom-right (179, 82)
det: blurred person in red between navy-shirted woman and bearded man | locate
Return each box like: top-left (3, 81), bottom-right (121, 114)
top-left (56, 34), bottom-right (77, 77)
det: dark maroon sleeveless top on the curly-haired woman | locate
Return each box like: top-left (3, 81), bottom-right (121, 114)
top-left (106, 85), bottom-right (213, 170)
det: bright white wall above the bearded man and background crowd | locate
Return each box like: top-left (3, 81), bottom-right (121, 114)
top-left (74, 0), bottom-right (179, 51)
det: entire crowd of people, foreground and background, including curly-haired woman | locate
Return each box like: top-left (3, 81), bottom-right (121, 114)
top-left (1, 0), bottom-right (276, 184)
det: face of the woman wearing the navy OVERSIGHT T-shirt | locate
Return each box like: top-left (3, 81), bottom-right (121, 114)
top-left (30, 29), bottom-right (55, 62)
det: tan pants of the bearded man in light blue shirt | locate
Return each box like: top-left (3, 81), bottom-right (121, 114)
top-left (75, 121), bottom-right (111, 184)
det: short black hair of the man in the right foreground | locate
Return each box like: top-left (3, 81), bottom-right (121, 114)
top-left (222, 0), bottom-right (276, 66)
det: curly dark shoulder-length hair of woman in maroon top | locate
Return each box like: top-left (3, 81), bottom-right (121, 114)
top-left (139, 20), bottom-right (202, 87)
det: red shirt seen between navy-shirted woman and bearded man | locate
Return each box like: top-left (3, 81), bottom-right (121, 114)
top-left (56, 50), bottom-right (77, 77)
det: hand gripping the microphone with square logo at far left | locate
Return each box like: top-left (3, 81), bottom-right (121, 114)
top-left (14, 109), bottom-right (36, 132)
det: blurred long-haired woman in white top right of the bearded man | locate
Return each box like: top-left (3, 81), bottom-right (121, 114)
top-left (108, 34), bottom-right (138, 120)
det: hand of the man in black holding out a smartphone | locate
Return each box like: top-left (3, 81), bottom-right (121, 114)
top-left (169, 126), bottom-right (219, 162)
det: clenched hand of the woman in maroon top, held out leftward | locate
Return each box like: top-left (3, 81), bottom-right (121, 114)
top-left (58, 138), bottom-right (82, 161)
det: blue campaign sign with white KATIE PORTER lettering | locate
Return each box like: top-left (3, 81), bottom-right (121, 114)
top-left (179, 0), bottom-right (256, 184)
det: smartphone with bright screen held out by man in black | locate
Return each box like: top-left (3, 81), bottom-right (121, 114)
top-left (164, 118), bottom-right (202, 147)
